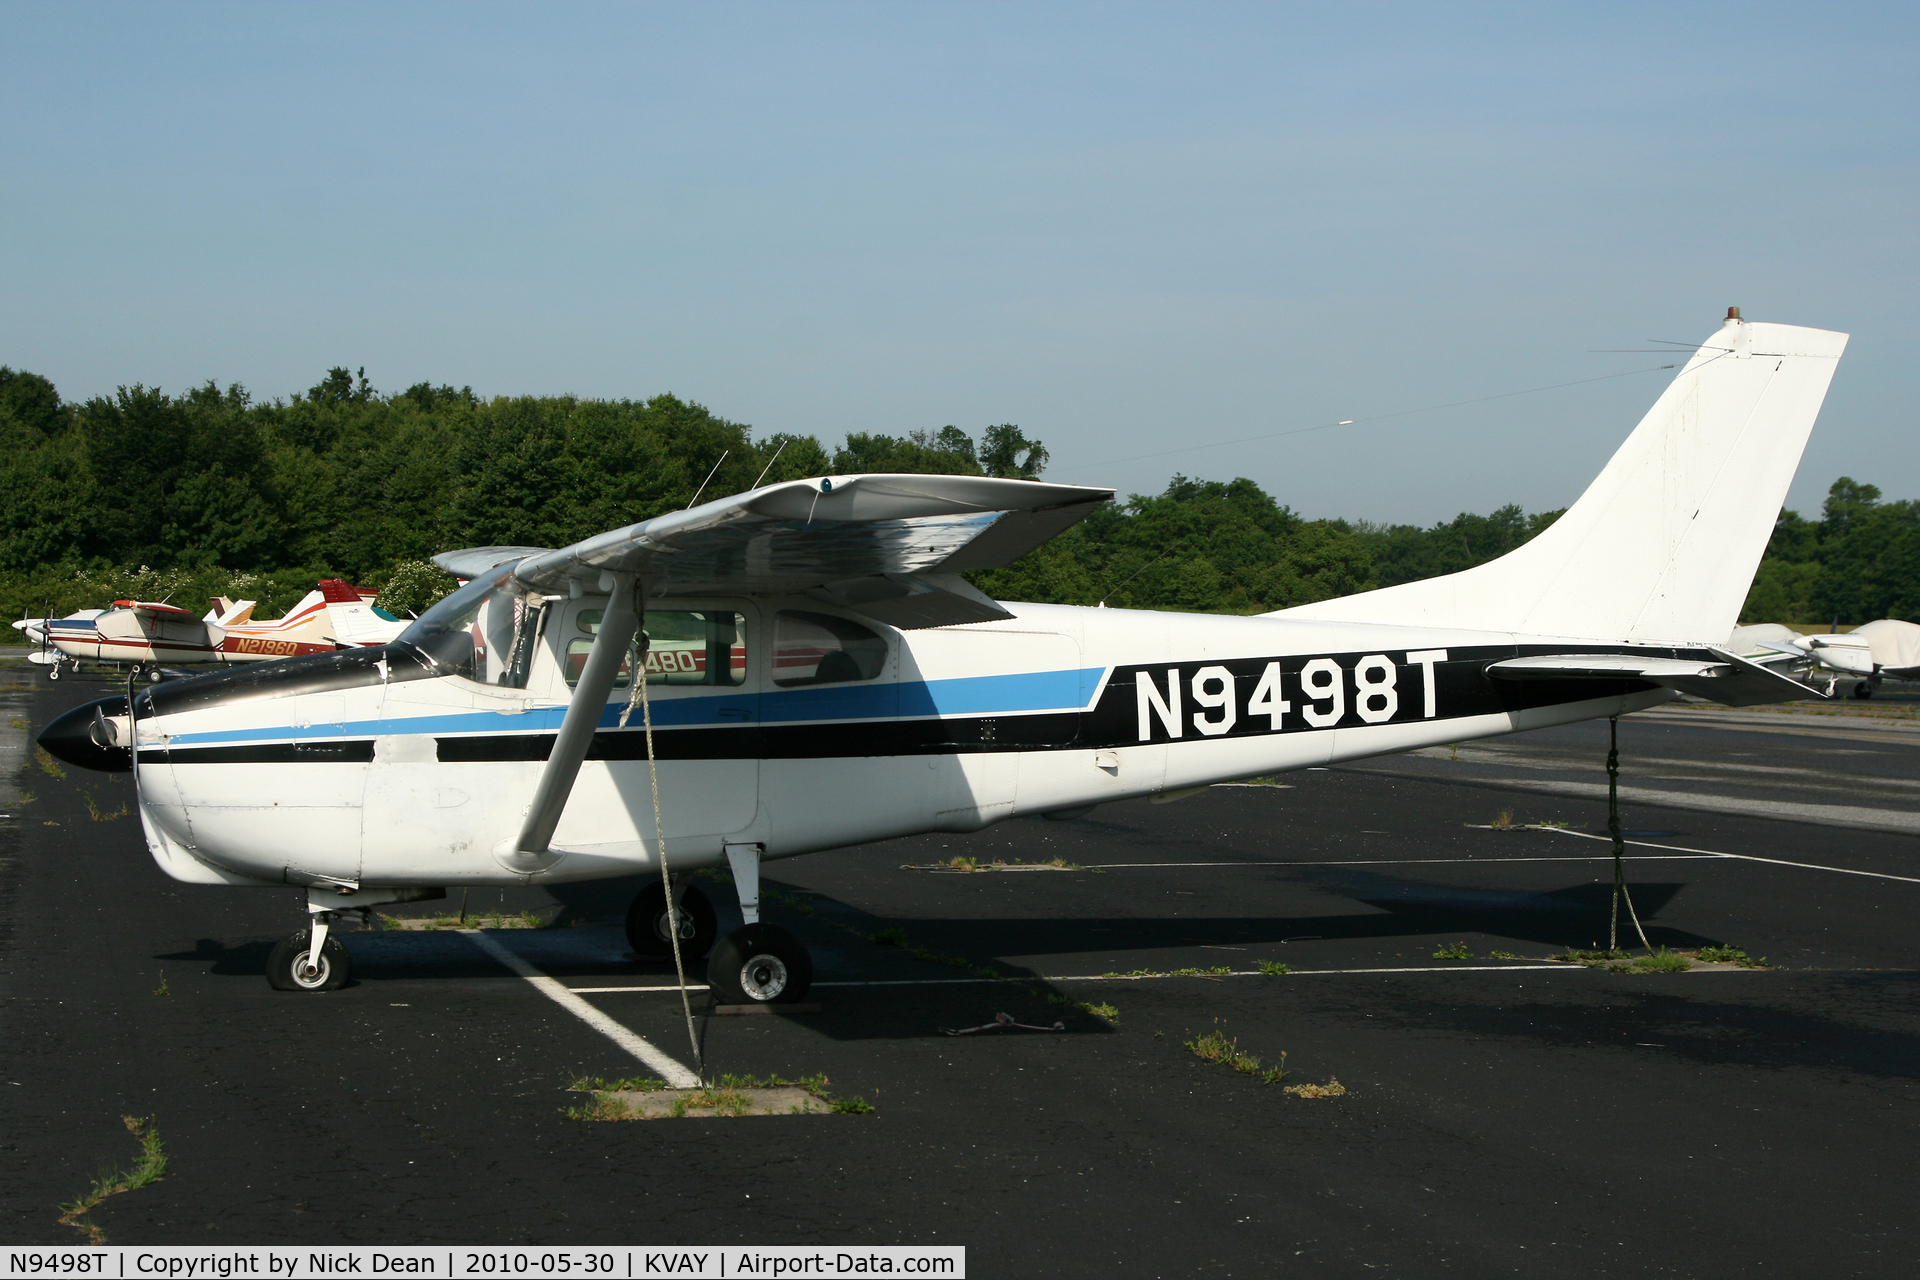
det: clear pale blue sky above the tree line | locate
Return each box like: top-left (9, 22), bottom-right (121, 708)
top-left (0, 2), bottom-right (1920, 522)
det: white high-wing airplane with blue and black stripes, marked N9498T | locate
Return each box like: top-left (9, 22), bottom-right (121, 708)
top-left (40, 313), bottom-right (1847, 1004)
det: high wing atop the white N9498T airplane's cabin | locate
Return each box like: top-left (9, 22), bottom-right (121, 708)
top-left (434, 474), bottom-right (1114, 628)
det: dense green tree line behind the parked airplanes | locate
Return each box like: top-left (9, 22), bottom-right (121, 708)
top-left (0, 367), bottom-right (1889, 639)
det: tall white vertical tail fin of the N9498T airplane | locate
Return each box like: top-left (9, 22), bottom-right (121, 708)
top-left (1269, 307), bottom-right (1847, 645)
